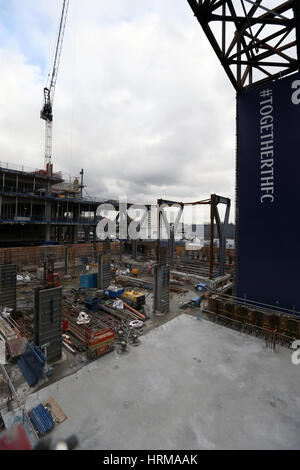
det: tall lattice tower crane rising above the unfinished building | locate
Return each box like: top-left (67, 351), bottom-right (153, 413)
top-left (40, 0), bottom-right (69, 175)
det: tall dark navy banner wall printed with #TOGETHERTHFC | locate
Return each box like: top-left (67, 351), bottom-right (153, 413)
top-left (235, 73), bottom-right (300, 312)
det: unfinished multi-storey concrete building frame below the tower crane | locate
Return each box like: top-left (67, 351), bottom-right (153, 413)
top-left (0, 164), bottom-right (100, 246)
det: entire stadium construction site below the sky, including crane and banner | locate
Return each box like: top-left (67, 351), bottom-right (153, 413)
top-left (0, 0), bottom-right (300, 450)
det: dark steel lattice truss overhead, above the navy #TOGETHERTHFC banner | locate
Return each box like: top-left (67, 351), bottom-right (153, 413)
top-left (187, 0), bottom-right (300, 91)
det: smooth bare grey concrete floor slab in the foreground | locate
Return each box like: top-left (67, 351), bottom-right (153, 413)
top-left (21, 314), bottom-right (300, 450)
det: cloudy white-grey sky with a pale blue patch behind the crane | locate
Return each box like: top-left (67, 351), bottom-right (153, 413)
top-left (0, 0), bottom-right (235, 220)
